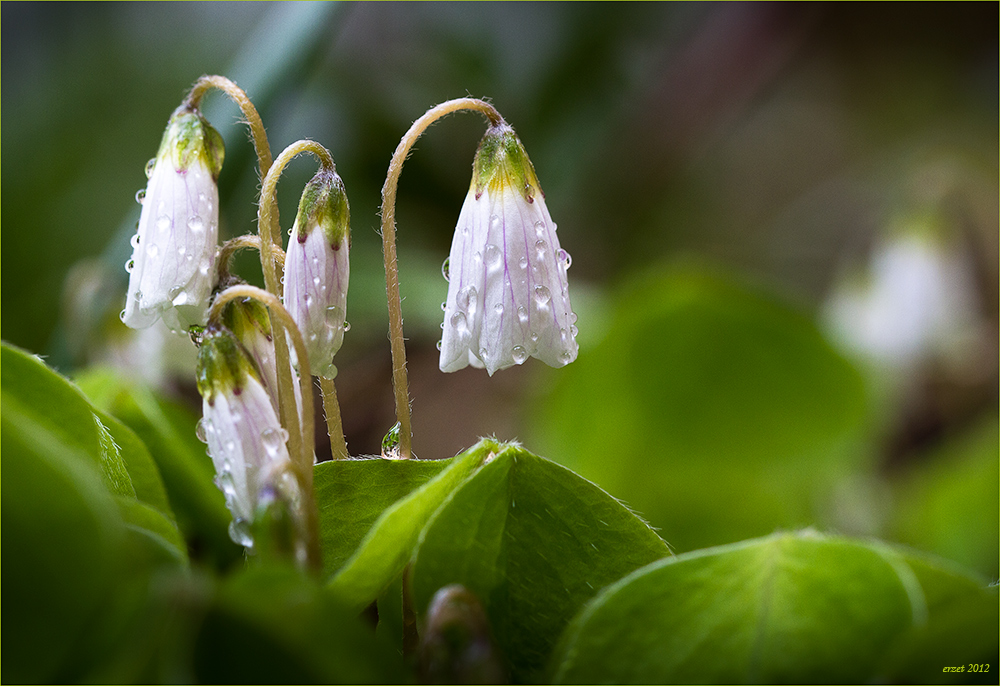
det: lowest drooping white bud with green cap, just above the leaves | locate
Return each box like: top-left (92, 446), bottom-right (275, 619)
top-left (198, 329), bottom-right (300, 548)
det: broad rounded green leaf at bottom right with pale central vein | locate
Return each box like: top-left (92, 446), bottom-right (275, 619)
top-left (550, 531), bottom-right (995, 683)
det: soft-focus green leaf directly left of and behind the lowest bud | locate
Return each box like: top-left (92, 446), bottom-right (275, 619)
top-left (77, 369), bottom-right (243, 567)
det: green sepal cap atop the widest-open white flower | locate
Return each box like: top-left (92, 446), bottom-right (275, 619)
top-left (472, 123), bottom-right (544, 203)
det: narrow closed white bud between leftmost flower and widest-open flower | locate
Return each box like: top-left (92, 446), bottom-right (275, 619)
top-left (284, 169), bottom-right (351, 379)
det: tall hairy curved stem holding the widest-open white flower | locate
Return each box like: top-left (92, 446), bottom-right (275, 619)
top-left (382, 98), bottom-right (503, 459)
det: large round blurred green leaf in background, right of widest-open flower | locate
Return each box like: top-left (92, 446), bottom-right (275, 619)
top-left (530, 268), bottom-right (869, 550)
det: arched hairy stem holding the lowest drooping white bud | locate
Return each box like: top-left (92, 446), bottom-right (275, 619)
top-left (208, 284), bottom-right (321, 571)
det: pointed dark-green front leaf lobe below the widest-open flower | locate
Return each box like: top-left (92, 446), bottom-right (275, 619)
top-left (412, 445), bottom-right (670, 681)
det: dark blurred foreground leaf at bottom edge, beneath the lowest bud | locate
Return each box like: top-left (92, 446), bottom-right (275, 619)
top-left (194, 567), bottom-right (408, 684)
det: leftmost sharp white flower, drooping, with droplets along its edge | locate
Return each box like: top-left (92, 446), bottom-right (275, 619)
top-left (121, 105), bottom-right (224, 333)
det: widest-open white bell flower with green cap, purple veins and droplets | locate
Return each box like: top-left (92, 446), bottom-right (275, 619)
top-left (440, 124), bottom-right (577, 376)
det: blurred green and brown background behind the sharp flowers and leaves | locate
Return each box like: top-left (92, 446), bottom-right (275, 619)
top-left (0, 2), bottom-right (1000, 580)
